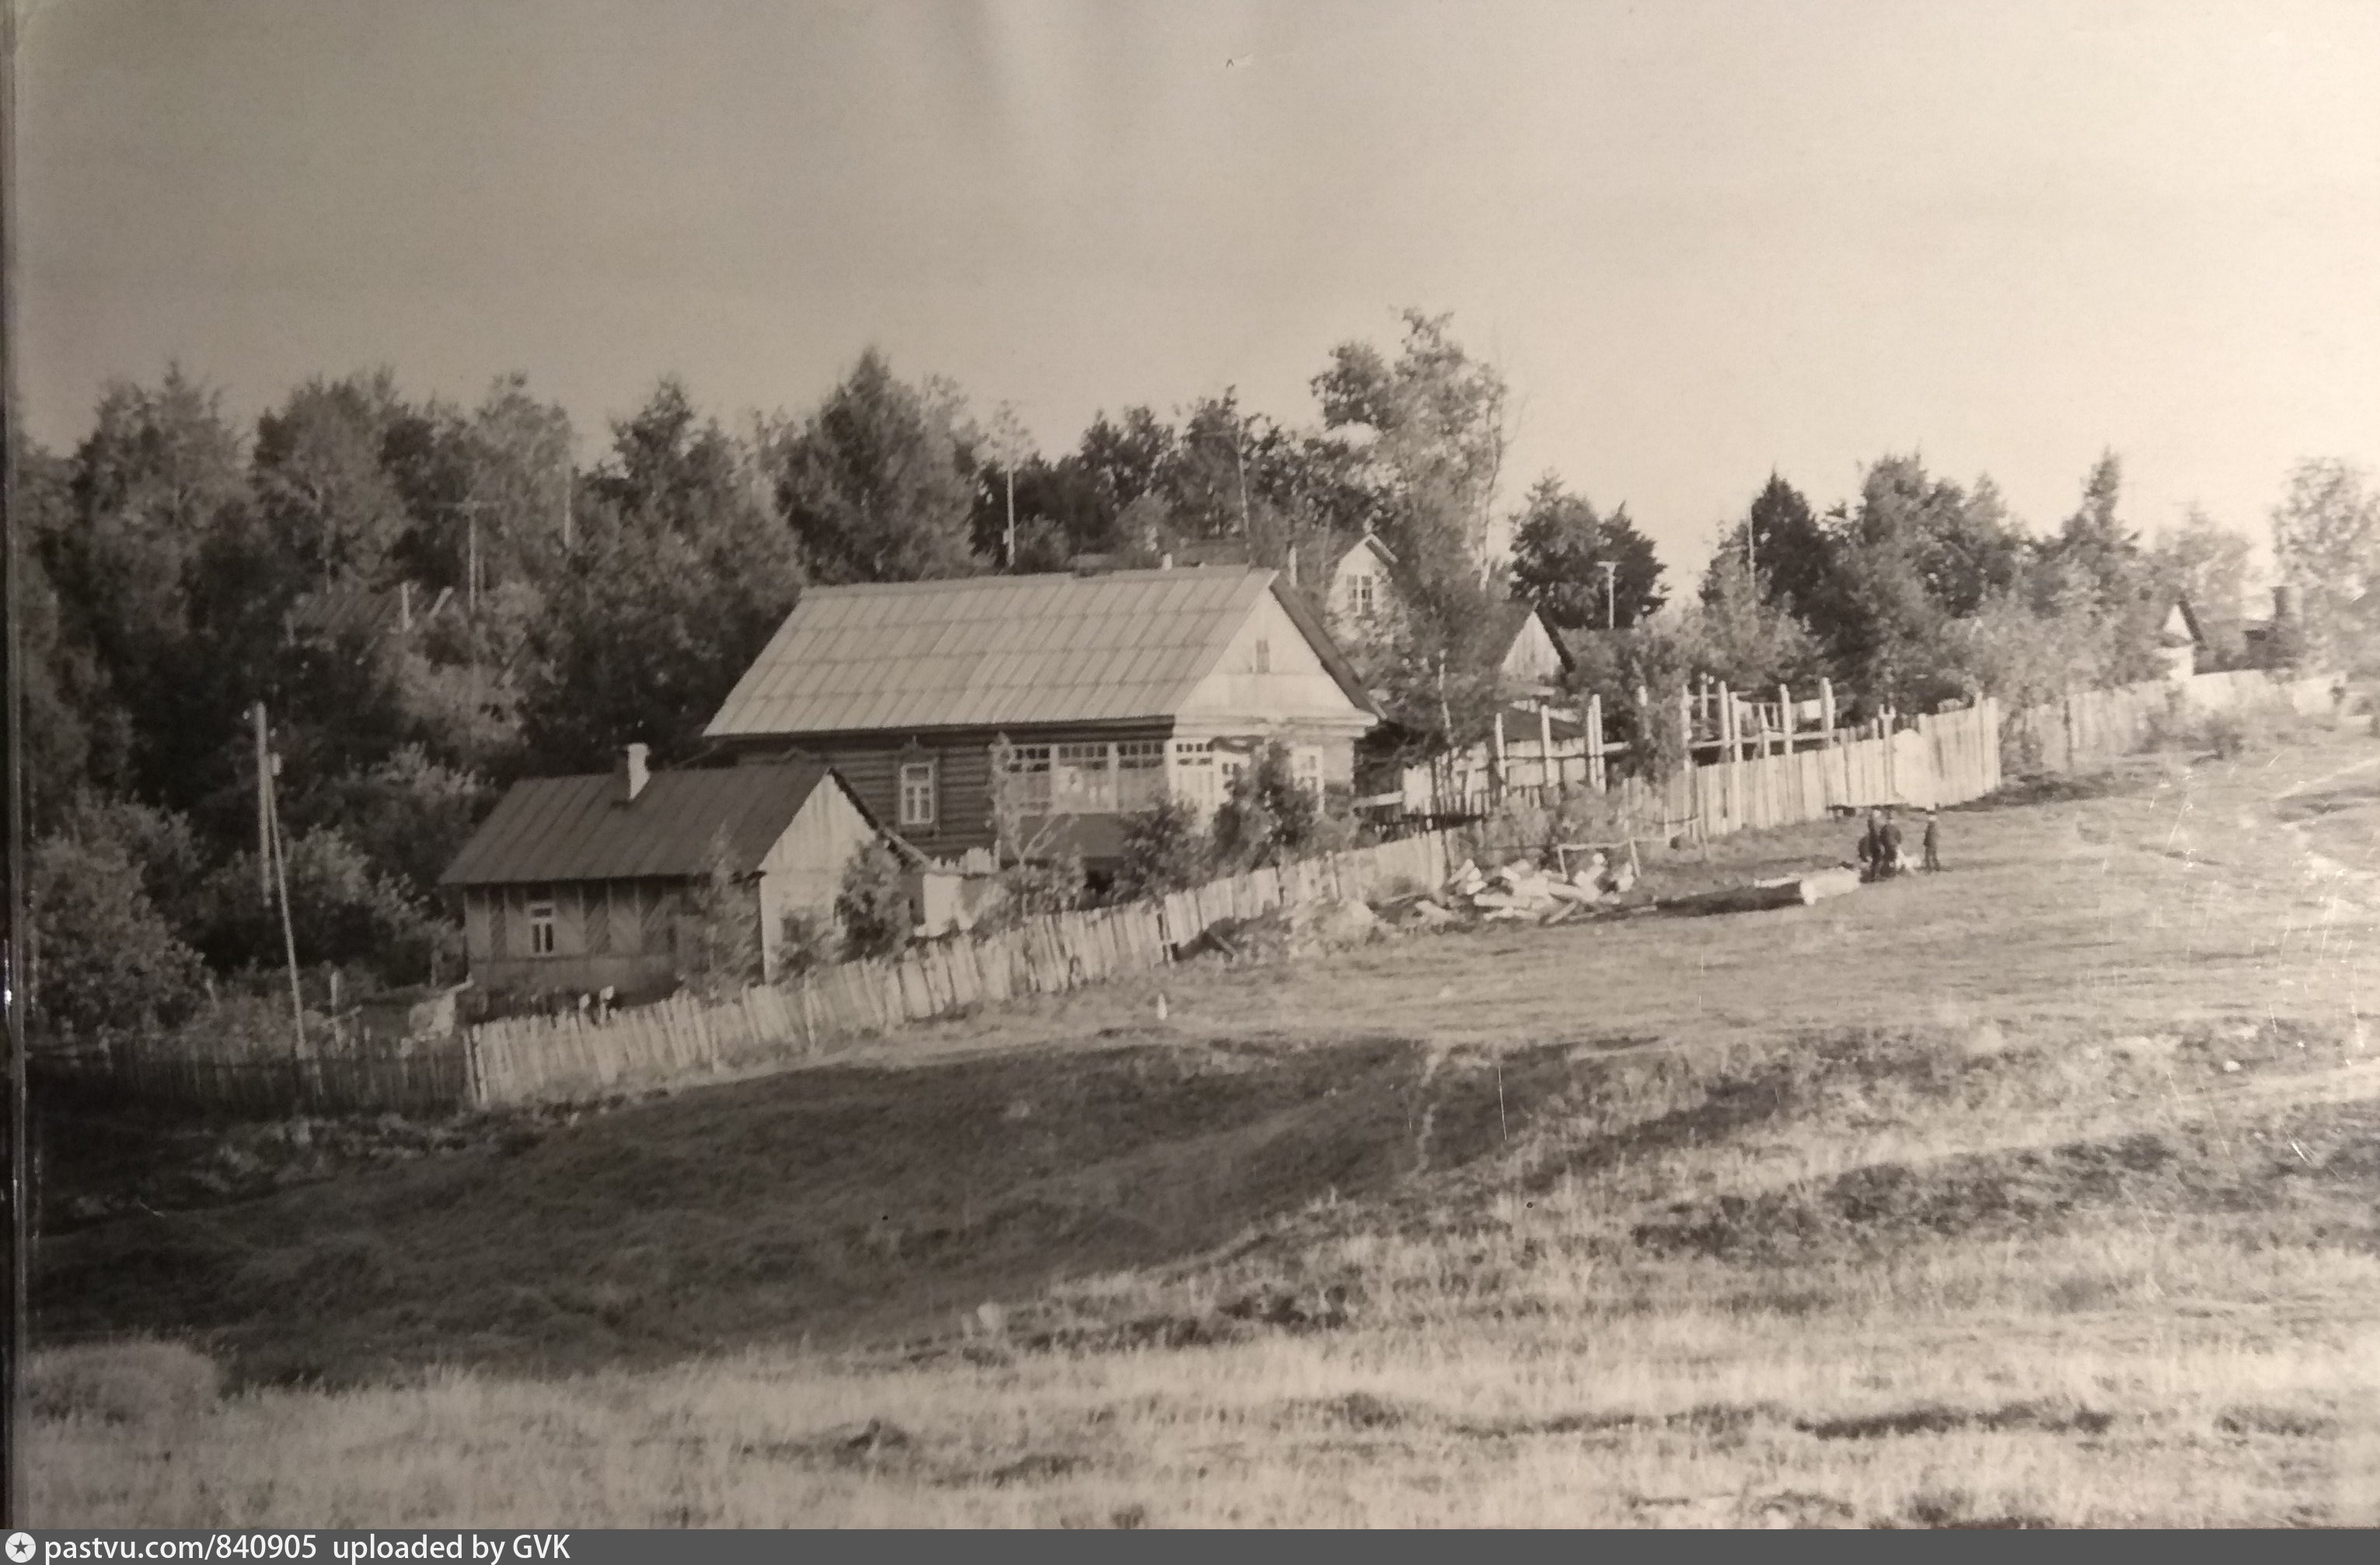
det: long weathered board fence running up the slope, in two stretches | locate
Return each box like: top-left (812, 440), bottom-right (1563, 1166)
top-left (54, 673), bottom-right (2330, 1113)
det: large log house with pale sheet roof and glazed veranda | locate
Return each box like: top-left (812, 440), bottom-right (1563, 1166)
top-left (704, 566), bottom-right (1378, 866)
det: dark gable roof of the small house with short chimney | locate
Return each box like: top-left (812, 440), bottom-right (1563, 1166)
top-left (438, 761), bottom-right (874, 885)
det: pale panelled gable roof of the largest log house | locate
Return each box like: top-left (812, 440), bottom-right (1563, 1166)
top-left (702, 569), bottom-right (1378, 740)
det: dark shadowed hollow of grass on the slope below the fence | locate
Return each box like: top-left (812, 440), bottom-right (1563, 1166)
top-left (36, 1040), bottom-right (1599, 1384)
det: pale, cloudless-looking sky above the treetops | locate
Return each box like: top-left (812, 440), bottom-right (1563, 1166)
top-left (16, 0), bottom-right (2380, 566)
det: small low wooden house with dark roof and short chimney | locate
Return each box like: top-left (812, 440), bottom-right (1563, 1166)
top-left (440, 744), bottom-right (878, 999)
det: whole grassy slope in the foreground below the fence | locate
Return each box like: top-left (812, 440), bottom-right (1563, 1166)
top-left (31, 735), bottom-right (2380, 1527)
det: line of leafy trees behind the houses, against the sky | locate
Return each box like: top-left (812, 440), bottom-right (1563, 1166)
top-left (19, 312), bottom-right (2380, 1037)
